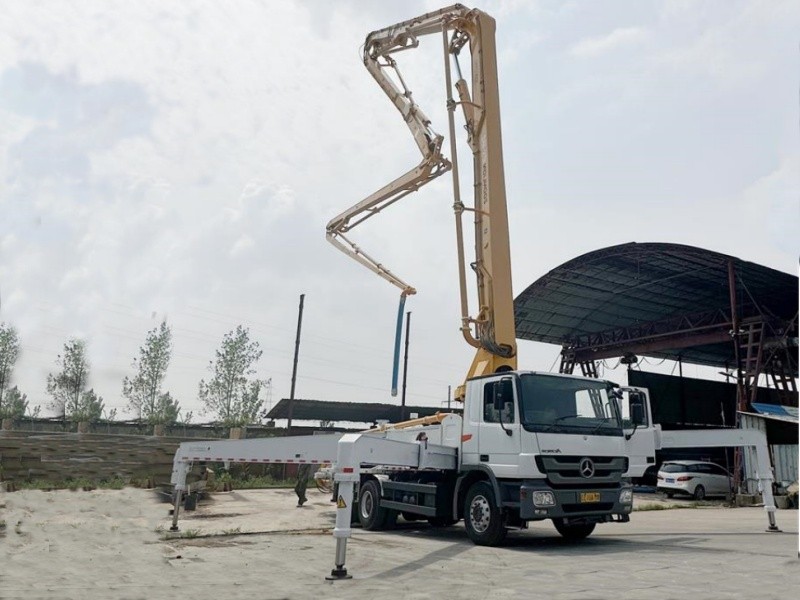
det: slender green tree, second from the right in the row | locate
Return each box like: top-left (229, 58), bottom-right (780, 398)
top-left (122, 321), bottom-right (178, 425)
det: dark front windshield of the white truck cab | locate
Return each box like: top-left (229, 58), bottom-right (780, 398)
top-left (520, 374), bottom-right (622, 436)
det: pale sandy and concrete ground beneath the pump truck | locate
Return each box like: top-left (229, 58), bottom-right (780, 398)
top-left (0, 489), bottom-right (800, 600)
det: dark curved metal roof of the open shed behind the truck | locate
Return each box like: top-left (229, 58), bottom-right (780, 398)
top-left (514, 243), bottom-right (798, 370)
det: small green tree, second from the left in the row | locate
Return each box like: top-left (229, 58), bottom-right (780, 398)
top-left (47, 338), bottom-right (94, 418)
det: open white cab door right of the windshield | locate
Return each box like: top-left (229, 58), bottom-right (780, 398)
top-left (620, 387), bottom-right (656, 477)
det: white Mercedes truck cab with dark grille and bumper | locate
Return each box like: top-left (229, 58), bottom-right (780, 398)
top-left (454, 371), bottom-right (633, 543)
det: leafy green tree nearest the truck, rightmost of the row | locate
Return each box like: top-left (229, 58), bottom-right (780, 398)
top-left (199, 325), bottom-right (265, 427)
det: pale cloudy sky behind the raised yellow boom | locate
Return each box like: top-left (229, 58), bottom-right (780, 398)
top-left (0, 0), bottom-right (800, 422)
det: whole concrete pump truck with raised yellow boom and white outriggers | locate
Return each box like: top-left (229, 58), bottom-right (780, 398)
top-left (172, 4), bottom-right (775, 579)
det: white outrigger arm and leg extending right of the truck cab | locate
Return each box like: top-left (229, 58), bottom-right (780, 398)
top-left (656, 428), bottom-right (778, 531)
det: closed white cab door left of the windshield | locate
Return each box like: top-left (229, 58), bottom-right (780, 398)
top-left (478, 377), bottom-right (520, 477)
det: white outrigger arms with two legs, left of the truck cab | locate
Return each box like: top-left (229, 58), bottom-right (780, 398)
top-left (171, 428), bottom-right (460, 579)
